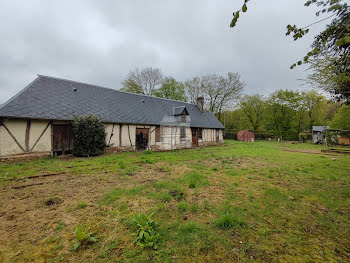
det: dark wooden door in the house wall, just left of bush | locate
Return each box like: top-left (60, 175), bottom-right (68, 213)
top-left (53, 125), bottom-right (73, 155)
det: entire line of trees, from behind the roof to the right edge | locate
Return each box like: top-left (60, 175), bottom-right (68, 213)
top-left (121, 67), bottom-right (350, 140)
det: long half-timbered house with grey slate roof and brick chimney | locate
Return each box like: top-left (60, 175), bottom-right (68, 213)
top-left (0, 75), bottom-right (224, 156)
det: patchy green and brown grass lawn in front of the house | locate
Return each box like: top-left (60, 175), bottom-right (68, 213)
top-left (0, 141), bottom-right (350, 262)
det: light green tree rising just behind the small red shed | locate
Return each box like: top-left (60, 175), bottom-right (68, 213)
top-left (240, 94), bottom-right (266, 133)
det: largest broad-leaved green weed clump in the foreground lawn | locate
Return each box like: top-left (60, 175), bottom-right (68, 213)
top-left (132, 213), bottom-right (159, 249)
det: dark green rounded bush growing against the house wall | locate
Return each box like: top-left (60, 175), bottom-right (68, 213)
top-left (73, 115), bottom-right (106, 157)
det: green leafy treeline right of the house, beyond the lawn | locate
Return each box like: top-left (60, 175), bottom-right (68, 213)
top-left (220, 90), bottom-right (350, 140)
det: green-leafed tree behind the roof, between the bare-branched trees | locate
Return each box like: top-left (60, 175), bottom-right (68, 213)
top-left (153, 77), bottom-right (187, 101)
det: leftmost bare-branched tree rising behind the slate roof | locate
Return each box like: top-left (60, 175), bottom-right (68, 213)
top-left (121, 67), bottom-right (163, 95)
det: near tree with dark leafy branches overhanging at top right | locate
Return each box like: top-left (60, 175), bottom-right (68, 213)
top-left (230, 0), bottom-right (350, 103)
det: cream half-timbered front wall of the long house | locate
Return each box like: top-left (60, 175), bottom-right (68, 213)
top-left (0, 119), bottom-right (223, 156)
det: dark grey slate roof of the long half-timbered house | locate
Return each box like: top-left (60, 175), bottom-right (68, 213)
top-left (0, 75), bottom-right (224, 129)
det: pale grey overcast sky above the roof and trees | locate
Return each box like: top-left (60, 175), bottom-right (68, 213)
top-left (0, 0), bottom-right (325, 103)
